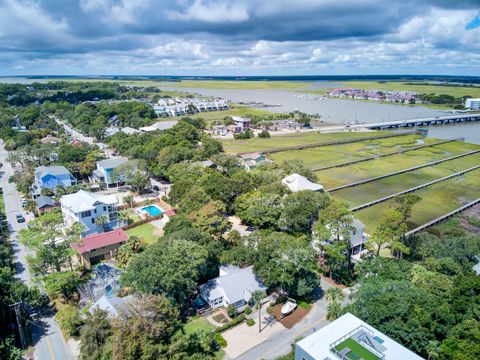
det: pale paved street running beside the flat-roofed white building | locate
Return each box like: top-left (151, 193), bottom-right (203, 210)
top-left (235, 280), bottom-right (340, 360)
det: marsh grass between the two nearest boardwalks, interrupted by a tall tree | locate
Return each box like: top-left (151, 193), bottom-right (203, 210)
top-left (355, 170), bottom-right (480, 233)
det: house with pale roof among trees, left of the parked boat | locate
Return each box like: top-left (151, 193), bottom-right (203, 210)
top-left (200, 265), bottom-right (267, 309)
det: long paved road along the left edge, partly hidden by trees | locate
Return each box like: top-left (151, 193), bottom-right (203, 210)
top-left (0, 140), bottom-right (72, 360)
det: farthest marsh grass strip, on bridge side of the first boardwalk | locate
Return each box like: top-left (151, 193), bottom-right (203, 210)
top-left (222, 131), bottom-right (388, 153)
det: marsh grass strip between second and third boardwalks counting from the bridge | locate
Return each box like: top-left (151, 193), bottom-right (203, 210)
top-left (316, 140), bottom-right (480, 189)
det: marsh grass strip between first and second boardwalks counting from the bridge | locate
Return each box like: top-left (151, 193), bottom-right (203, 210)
top-left (267, 135), bottom-right (428, 167)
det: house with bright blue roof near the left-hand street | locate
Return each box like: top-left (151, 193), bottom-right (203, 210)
top-left (32, 166), bottom-right (77, 198)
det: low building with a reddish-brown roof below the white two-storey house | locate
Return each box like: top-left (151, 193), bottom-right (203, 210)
top-left (70, 229), bottom-right (128, 268)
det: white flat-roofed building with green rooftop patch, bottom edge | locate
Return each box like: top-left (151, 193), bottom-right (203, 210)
top-left (295, 313), bottom-right (422, 360)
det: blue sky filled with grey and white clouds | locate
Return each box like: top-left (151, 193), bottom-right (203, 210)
top-left (0, 0), bottom-right (480, 76)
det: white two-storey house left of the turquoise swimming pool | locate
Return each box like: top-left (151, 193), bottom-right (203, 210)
top-left (60, 190), bottom-right (119, 236)
